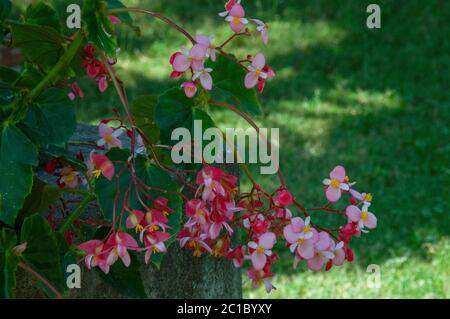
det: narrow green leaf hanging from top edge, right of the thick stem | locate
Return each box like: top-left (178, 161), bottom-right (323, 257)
top-left (82, 0), bottom-right (117, 57)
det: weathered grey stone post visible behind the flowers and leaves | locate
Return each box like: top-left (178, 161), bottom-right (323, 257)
top-left (17, 125), bottom-right (242, 299)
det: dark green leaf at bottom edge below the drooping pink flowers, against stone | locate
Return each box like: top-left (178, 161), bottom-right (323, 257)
top-left (96, 253), bottom-right (148, 299)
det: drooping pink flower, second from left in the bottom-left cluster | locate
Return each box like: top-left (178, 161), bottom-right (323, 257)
top-left (105, 232), bottom-right (138, 267)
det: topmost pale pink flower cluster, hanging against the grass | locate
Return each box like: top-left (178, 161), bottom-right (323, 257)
top-left (169, 0), bottom-right (275, 98)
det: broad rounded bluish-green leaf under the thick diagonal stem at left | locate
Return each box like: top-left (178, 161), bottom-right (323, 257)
top-left (23, 88), bottom-right (76, 146)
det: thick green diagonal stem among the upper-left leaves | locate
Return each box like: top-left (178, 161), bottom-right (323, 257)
top-left (25, 32), bottom-right (83, 101)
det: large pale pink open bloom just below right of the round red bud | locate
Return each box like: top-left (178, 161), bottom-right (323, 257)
top-left (283, 217), bottom-right (318, 259)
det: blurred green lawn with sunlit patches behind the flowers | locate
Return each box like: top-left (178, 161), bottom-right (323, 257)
top-left (17, 0), bottom-right (450, 298)
